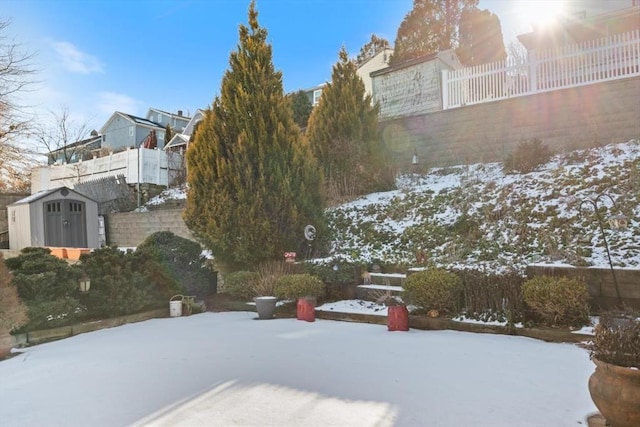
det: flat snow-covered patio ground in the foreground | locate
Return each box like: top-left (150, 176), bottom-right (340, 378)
top-left (0, 312), bottom-right (596, 427)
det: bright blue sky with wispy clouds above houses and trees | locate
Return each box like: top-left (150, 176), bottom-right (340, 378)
top-left (5, 0), bottom-right (554, 129)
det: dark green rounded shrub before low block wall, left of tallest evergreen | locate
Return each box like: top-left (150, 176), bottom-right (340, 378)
top-left (136, 231), bottom-right (214, 297)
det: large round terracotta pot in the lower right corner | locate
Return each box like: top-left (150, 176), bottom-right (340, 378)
top-left (589, 358), bottom-right (640, 427)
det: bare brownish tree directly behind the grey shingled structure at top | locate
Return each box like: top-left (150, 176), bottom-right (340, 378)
top-left (389, 0), bottom-right (478, 65)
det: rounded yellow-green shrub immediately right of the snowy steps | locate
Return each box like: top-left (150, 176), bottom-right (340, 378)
top-left (402, 269), bottom-right (460, 312)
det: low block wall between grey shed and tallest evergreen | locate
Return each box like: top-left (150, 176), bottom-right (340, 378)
top-left (105, 209), bottom-right (195, 247)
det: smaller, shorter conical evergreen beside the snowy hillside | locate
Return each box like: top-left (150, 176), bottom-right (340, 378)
top-left (307, 48), bottom-right (394, 201)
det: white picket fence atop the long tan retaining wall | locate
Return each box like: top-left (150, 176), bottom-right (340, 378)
top-left (442, 30), bottom-right (640, 110)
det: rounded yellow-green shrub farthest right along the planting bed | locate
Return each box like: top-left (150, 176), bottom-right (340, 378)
top-left (522, 276), bottom-right (589, 326)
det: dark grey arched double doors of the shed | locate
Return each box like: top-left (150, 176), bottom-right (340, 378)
top-left (44, 199), bottom-right (87, 248)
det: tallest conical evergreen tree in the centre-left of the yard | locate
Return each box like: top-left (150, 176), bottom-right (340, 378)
top-left (184, 1), bottom-right (324, 267)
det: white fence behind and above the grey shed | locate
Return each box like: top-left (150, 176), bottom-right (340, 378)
top-left (31, 148), bottom-right (183, 193)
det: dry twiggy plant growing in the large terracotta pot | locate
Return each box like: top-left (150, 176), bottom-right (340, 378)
top-left (589, 309), bottom-right (640, 369)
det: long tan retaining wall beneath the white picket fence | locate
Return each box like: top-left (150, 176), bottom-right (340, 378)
top-left (380, 77), bottom-right (640, 171)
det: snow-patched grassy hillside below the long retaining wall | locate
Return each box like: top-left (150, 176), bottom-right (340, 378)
top-left (150, 140), bottom-right (640, 270)
